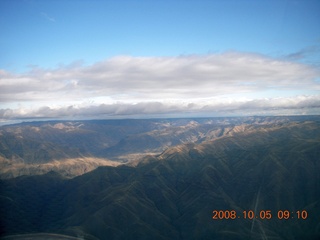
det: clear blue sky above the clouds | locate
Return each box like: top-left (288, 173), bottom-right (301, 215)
top-left (0, 0), bottom-right (320, 71)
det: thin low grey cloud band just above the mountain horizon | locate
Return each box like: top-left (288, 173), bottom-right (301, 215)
top-left (0, 96), bottom-right (320, 120)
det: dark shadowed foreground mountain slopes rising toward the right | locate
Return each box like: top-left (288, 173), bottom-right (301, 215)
top-left (0, 118), bottom-right (320, 240)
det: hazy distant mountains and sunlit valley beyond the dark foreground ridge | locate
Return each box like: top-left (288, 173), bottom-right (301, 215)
top-left (0, 116), bottom-right (319, 178)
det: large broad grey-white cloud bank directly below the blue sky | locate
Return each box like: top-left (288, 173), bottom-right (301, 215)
top-left (0, 52), bottom-right (320, 101)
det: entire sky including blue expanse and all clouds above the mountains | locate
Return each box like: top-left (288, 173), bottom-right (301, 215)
top-left (0, 0), bottom-right (320, 123)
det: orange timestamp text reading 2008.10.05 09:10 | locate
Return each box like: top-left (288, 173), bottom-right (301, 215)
top-left (212, 210), bottom-right (308, 220)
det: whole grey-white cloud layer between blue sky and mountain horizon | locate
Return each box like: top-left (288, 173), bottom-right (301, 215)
top-left (0, 52), bottom-right (320, 119)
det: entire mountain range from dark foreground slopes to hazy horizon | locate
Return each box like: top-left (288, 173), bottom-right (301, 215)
top-left (0, 116), bottom-right (320, 240)
